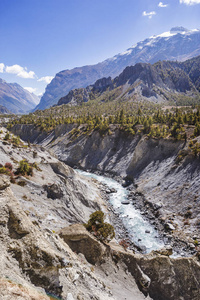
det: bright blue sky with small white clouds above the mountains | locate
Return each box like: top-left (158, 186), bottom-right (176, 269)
top-left (0, 0), bottom-right (200, 95)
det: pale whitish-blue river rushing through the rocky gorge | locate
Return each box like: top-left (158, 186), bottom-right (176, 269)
top-left (77, 170), bottom-right (164, 253)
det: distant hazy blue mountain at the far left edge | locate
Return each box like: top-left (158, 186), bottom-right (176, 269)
top-left (0, 79), bottom-right (39, 113)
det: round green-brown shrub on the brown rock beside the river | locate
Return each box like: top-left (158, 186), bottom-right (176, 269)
top-left (84, 210), bottom-right (115, 242)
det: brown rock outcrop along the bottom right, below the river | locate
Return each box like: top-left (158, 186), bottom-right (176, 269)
top-left (60, 224), bottom-right (200, 300)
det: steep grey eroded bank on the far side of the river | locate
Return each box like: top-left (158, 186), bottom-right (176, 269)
top-left (12, 124), bottom-right (200, 254)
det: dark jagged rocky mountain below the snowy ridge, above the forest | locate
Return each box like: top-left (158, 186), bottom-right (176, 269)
top-left (58, 56), bottom-right (200, 106)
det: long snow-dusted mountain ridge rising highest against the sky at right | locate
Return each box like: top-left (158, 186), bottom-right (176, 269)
top-left (36, 27), bottom-right (200, 109)
